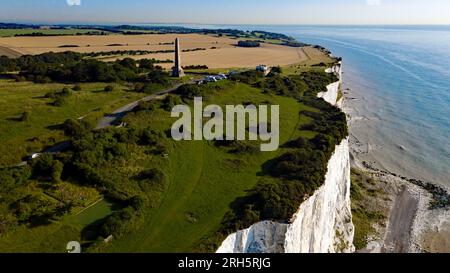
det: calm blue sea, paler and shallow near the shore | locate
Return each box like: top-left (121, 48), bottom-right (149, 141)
top-left (183, 25), bottom-right (450, 188)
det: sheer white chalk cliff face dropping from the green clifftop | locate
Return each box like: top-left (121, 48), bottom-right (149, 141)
top-left (217, 66), bottom-right (355, 253)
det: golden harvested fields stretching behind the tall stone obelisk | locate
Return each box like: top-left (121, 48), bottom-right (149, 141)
top-left (0, 34), bottom-right (323, 68)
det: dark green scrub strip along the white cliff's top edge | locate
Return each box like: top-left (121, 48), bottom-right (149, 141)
top-left (200, 72), bottom-right (348, 250)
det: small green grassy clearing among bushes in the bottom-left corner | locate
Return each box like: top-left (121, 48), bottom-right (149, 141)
top-left (0, 178), bottom-right (106, 253)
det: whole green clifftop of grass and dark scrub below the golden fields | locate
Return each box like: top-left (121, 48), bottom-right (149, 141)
top-left (0, 48), bottom-right (348, 252)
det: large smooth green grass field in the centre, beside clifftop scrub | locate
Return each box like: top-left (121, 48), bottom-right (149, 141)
top-left (98, 81), bottom-right (314, 252)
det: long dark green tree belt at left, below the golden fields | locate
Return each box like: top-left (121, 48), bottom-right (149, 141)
top-left (0, 52), bottom-right (169, 85)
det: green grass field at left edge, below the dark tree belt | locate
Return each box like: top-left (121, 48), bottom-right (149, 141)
top-left (0, 80), bottom-right (143, 166)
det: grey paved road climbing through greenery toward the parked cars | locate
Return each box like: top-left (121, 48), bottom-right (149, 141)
top-left (96, 83), bottom-right (184, 129)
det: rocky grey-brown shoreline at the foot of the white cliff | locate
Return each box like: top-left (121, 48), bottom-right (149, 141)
top-left (342, 84), bottom-right (450, 253)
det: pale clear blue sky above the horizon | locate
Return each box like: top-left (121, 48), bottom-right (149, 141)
top-left (0, 0), bottom-right (450, 24)
